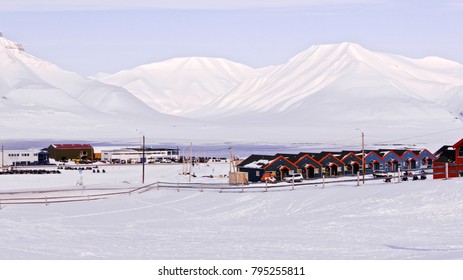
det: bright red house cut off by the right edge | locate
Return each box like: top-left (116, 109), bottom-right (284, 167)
top-left (432, 139), bottom-right (463, 179)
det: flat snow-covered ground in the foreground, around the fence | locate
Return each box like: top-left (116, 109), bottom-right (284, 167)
top-left (0, 163), bottom-right (463, 260)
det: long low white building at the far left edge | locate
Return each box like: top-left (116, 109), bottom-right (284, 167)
top-left (1, 150), bottom-right (48, 166)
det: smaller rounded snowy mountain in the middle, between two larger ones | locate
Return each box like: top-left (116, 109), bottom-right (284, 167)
top-left (100, 57), bottom-right (259, 115)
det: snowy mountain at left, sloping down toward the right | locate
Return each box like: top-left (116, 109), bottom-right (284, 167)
top-left (0, 37), bottom-right (194, 139)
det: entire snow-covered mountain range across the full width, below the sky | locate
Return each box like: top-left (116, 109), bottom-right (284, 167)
top-left (0, 37), bottom-right (463, 145)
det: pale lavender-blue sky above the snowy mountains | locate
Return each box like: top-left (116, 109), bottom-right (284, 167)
top-left (0, 0), bottom-right (463, 75)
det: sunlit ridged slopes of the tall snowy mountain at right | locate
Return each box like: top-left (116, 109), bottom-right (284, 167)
top-left (189, 43), bottom-right (463, 121)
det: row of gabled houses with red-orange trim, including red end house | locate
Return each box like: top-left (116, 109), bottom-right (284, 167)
top-left (237, 139), bottom-right (463, 182)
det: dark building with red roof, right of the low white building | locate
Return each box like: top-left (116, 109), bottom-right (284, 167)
top-left (46, 144), bottom-right (94, 161)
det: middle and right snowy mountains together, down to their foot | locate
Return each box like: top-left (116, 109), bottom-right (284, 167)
top-left (94, 43), bottom-right (463, 147)
